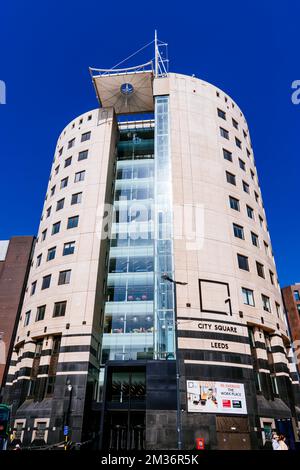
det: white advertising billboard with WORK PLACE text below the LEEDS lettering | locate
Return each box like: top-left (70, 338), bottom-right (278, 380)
top-left (187, 380), bottom-right (247, 415)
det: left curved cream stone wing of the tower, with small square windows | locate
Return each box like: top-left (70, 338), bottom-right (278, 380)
top-left (6, 109), bottom-right (116, 445)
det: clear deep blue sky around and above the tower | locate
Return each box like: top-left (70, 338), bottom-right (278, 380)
top-left (0, 0), bottom-right (300, 285)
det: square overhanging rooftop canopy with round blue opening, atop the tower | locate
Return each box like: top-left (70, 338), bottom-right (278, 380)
top-left (89, 61), bottom-right (154, 114)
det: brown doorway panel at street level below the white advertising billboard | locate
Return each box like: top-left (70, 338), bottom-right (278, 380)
top-left (216, 416), bottom-right (251, 450)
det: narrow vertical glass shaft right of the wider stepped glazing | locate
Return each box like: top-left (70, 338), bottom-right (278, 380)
top-left (154, 96), bottom-right (175, 359)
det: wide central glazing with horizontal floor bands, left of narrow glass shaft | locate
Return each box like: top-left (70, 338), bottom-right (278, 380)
top-left (101, 127), bottom-right (154, 364)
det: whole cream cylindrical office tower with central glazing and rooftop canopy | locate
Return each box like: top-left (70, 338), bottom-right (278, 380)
top-left (2, 42), bottom-right (299, 449)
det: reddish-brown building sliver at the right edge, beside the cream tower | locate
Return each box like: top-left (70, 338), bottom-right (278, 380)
top-left (281, 283), bottom-right (300, 373)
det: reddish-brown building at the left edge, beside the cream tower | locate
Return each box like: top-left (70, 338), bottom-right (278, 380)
top-left (0, 237), bottom-right (34, 391)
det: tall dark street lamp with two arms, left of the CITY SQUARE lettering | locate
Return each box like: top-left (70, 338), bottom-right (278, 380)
top-left (161, 273), bottom-right (187, 450)
